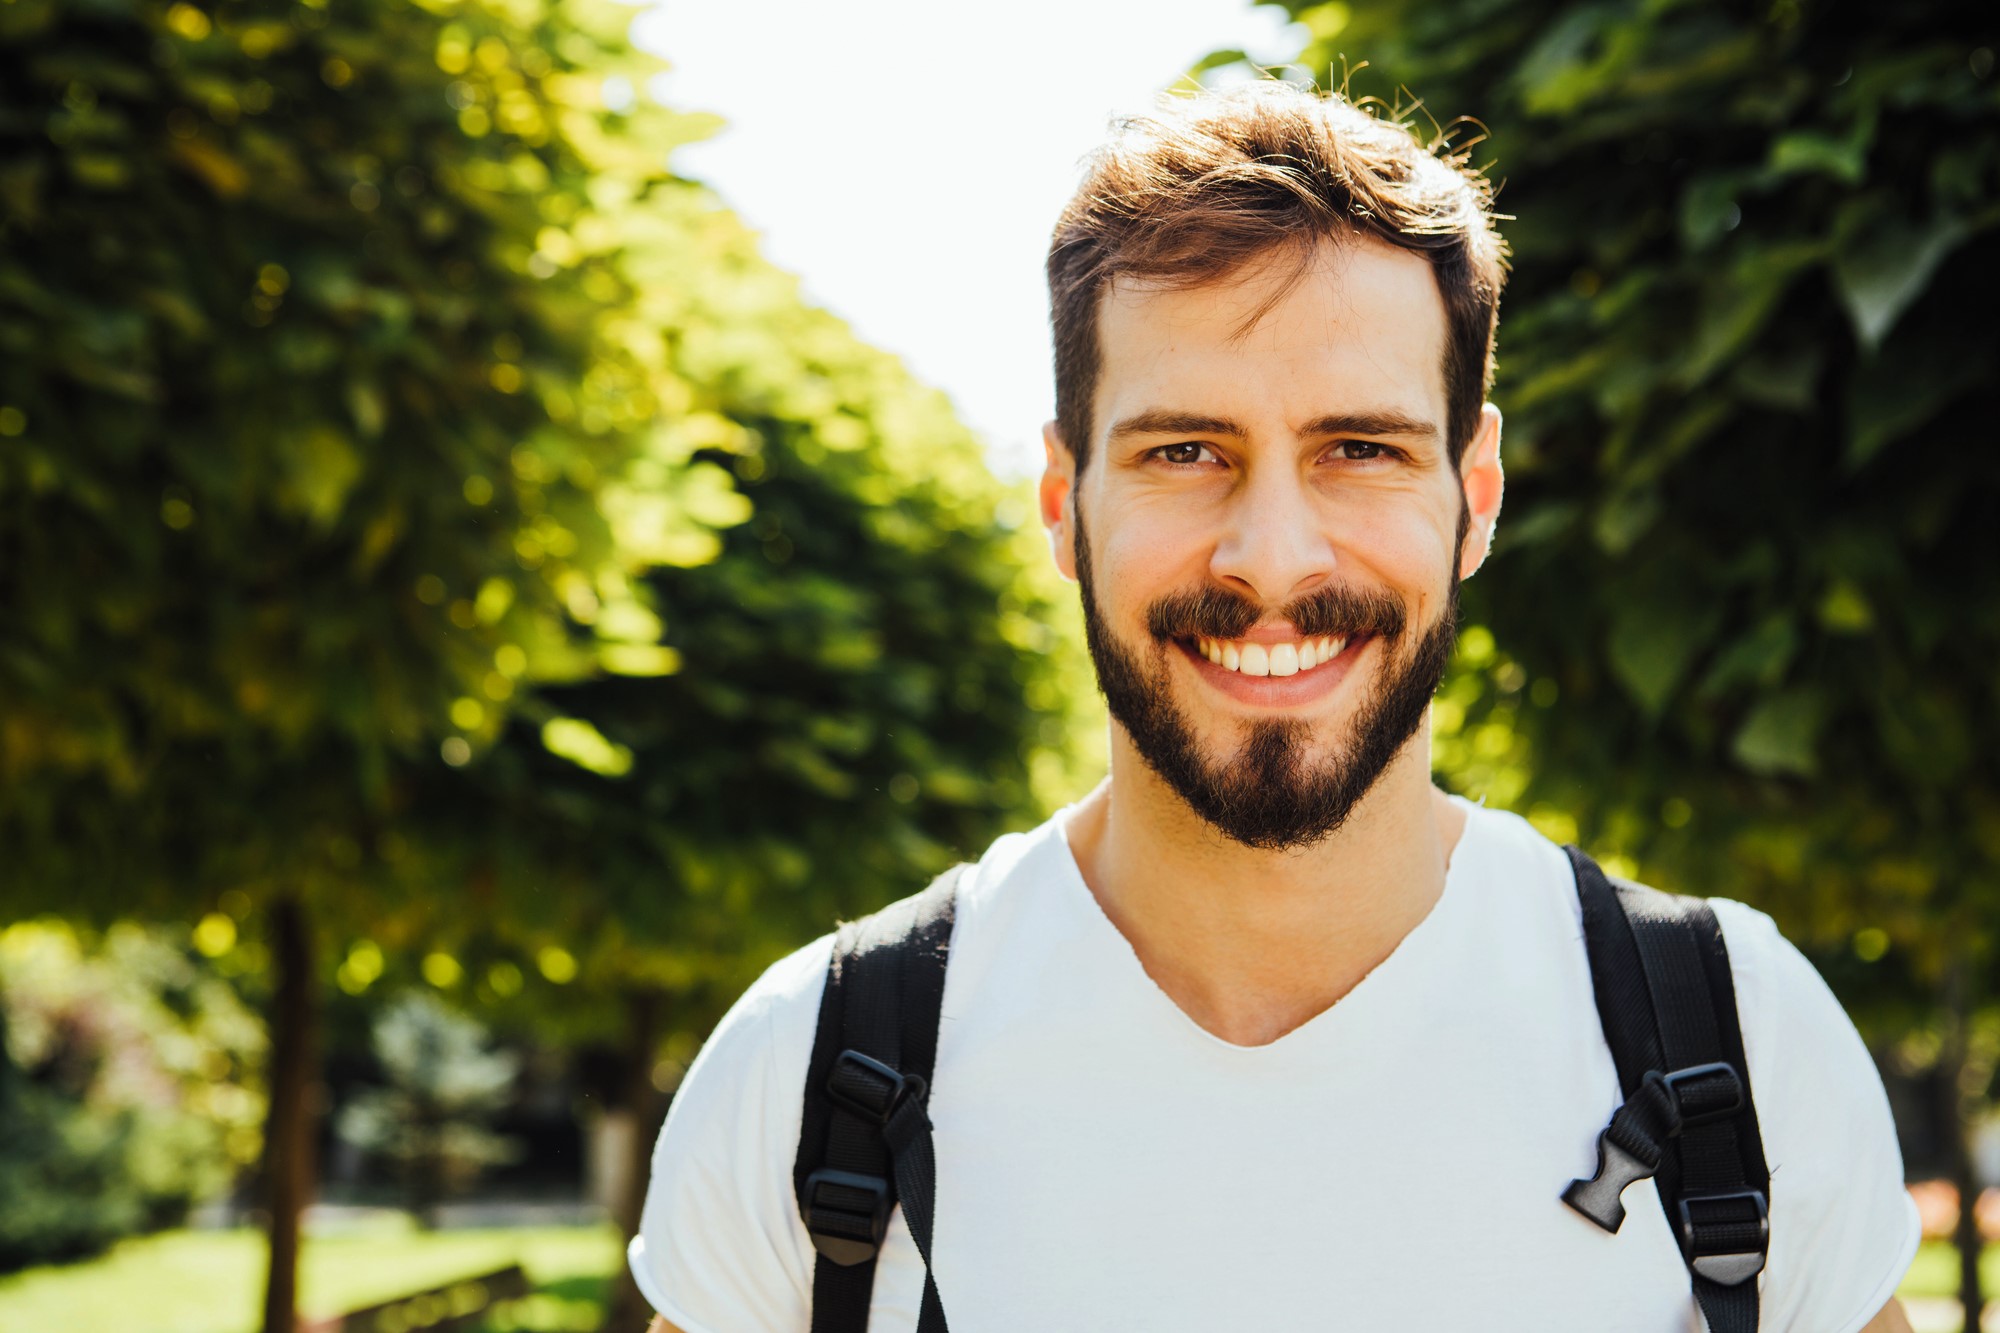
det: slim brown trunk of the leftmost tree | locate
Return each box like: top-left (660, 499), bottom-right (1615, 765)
top-left (264, 897), bottom-right (318, 1333)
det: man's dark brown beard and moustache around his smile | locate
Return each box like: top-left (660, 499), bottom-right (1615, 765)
top-left (1076, 506), bottom-right (1470, 851)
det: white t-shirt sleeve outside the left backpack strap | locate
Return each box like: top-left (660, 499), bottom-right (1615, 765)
top-left (626, 939), bottom-right (832, 1333)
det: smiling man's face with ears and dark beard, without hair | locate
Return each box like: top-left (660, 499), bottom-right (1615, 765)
top-left (1042, 240), bottom-right (1500, 849)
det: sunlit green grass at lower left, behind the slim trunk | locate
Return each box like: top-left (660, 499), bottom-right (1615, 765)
top-left (0, 1225), bottom-right (620, 1333)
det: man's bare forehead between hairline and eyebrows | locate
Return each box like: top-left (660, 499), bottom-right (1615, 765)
top-left (1092, 236), bottom-right (1446, 440)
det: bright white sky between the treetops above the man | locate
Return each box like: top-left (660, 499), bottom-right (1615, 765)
top-left (632, 0), bottom-right (1302, 476)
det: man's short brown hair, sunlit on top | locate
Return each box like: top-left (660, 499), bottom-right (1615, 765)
top-left (1048, 78), bottom-right (1506, 470)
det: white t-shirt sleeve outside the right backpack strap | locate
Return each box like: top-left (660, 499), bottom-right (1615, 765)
top-left (1716, 901), bottom-right (1920, 1333)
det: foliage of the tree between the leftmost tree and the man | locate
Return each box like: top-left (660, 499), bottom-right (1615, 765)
top-left (358, 184), bottom-right (1094, 1035)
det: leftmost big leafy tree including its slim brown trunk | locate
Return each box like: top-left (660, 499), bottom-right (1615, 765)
top-left (0, 0), bottom-right (742, 1333)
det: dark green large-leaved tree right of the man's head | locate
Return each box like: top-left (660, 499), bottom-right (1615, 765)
top-left (1256, 0), bottom-right (2000, 1327)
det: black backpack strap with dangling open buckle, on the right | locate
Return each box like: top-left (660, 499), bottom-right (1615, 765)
top-left (1562, 847), bottom-right (1770, 1333)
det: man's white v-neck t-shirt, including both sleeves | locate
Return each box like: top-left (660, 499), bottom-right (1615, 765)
top-left (630, 803), bottom-right (1918, 1333)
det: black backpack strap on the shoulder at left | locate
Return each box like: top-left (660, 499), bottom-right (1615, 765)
top-left (792, 865), bottom-right (964, 1333)
